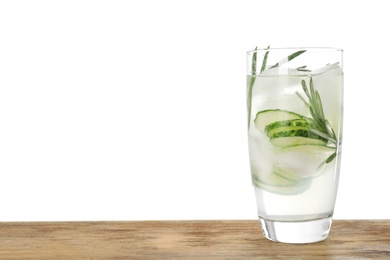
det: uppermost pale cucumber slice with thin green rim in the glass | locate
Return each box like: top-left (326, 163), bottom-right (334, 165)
top-left (254, 109), bottom-right (304, 133)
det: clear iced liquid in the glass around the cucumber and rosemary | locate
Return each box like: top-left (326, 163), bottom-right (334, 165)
top-left (248, 66), bottom-right (343, 221)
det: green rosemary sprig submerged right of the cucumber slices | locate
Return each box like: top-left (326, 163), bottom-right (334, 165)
top-left (297, 77), bottom-right (338, 163)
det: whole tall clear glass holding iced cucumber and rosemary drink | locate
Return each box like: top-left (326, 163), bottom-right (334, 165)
top-left (247, 47), bottom-right (343, 243)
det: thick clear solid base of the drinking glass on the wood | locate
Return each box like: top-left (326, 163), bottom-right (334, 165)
top-left (259, 217), bottom-right (332, 244)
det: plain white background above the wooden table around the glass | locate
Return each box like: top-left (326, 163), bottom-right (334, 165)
top-left (0, 0), bottom-right (390, 221)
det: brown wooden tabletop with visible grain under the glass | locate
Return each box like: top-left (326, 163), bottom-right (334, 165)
top-left (0, 220), bottom-right (390, 260)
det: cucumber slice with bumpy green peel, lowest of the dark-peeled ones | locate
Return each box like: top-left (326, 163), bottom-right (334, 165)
top-left (270, 127), bottom-right (327, 147)
